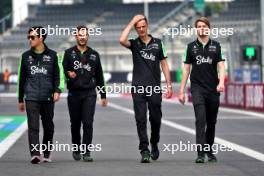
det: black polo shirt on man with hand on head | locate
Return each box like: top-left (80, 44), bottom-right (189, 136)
top-left (129, 35), bottom-right (167, 86)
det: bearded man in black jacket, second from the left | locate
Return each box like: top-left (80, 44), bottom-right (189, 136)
top-left (63, 26), bottom-right (107, 162)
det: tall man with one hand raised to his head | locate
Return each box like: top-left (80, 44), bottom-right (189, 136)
top-left (119, 15), bottom-right (172, 163)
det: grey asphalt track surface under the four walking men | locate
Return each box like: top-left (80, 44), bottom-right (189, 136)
top-left (0, 97), bottom-right (264, 176)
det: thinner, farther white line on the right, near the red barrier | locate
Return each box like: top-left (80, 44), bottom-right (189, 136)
top-left (162, 99), bottom-right (264, 119)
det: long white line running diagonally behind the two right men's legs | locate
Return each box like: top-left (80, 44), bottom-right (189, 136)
top-left (108, 103), bottom-right (264, 162)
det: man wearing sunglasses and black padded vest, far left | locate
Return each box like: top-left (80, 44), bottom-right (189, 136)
top-left (18, 26), bottom-right (63, 164)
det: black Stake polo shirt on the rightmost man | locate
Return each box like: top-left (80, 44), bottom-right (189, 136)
top-left (184, 39), bottom-right (225, 92)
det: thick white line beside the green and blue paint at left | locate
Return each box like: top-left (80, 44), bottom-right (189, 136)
top-left (0, 121), bottom-right (27, 158)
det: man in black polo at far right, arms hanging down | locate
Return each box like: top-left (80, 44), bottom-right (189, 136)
top-left (179, 17), bottom-right (225, 163)
